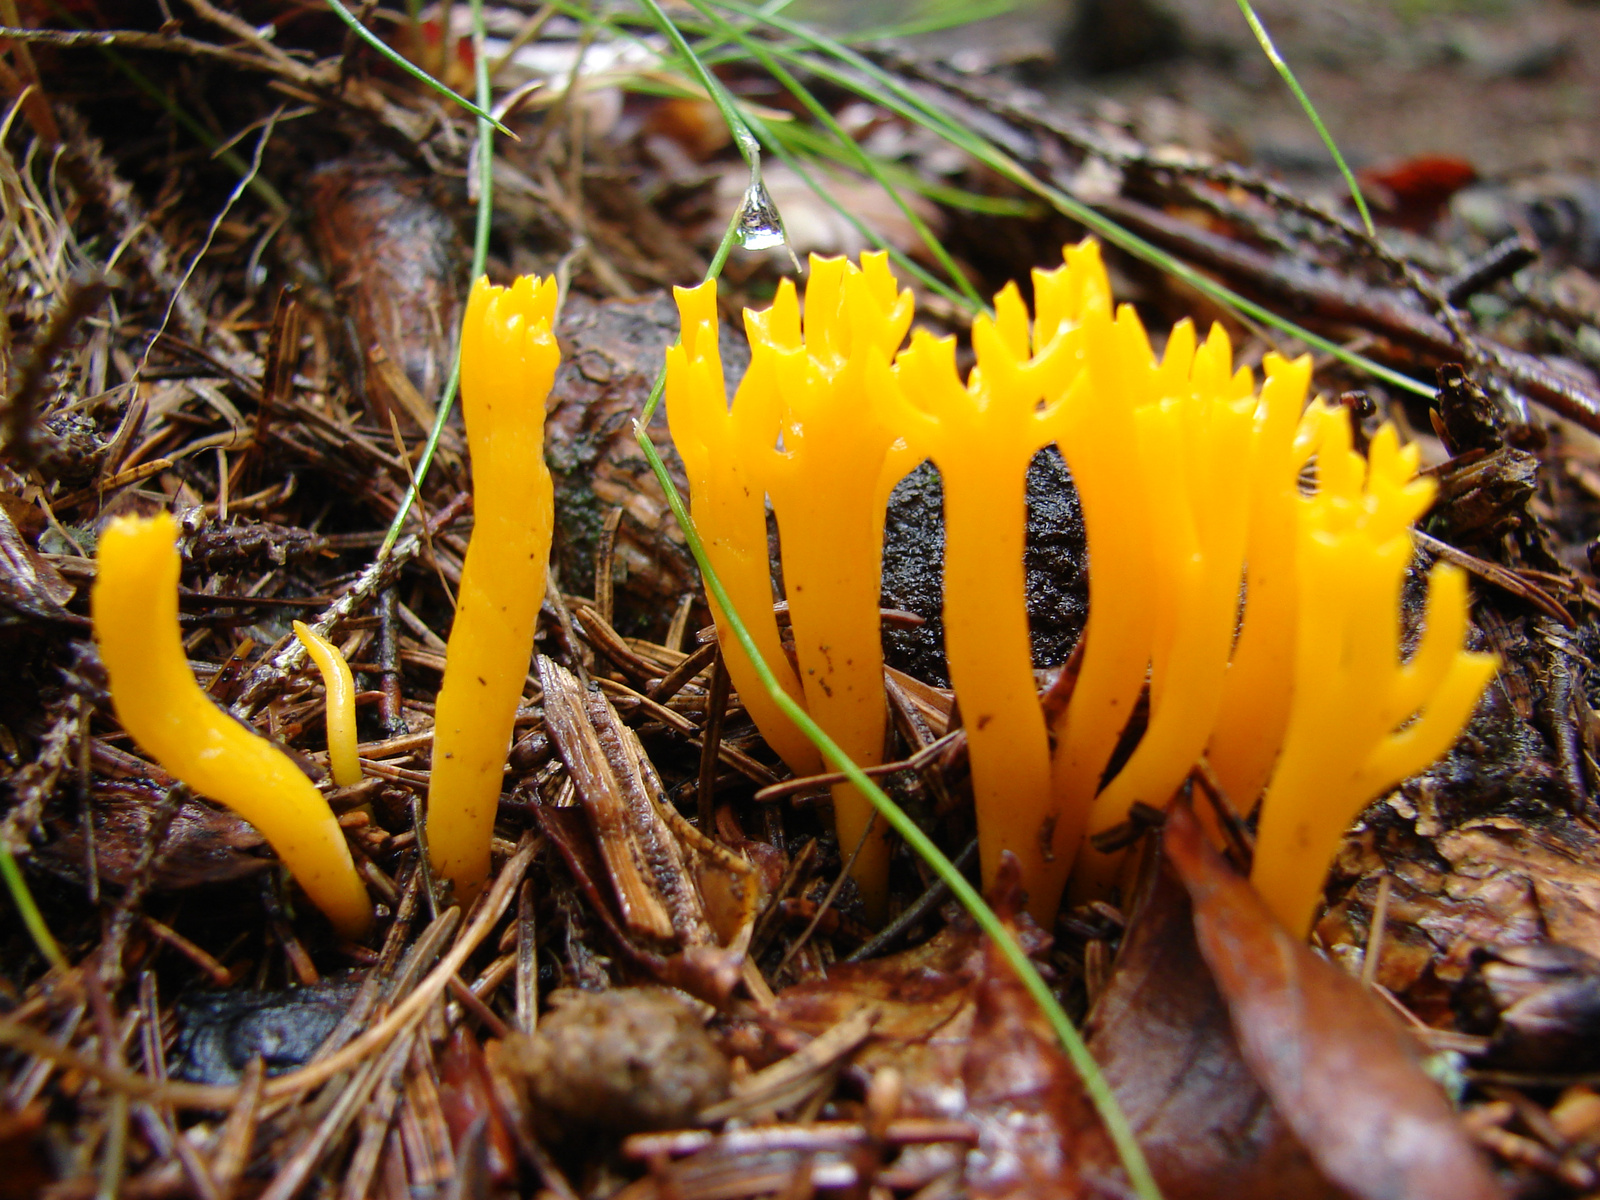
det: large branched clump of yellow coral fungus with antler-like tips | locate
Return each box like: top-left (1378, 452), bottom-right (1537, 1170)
top-left (666, 242), bottom-right (1496, 933)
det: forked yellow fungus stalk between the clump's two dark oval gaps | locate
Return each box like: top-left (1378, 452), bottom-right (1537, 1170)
top-left (898, 264), bottom-right (1098, 923)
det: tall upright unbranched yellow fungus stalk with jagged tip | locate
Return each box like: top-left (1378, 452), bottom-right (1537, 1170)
top-left (427, 275), bottom-right (560, 902)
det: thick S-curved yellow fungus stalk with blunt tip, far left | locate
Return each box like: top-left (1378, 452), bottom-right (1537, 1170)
top-left (90, 512), bottom-right (373, 938)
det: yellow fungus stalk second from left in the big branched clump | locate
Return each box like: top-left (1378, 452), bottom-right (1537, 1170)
top-left (748, 253), bottom-right (917, 920)
